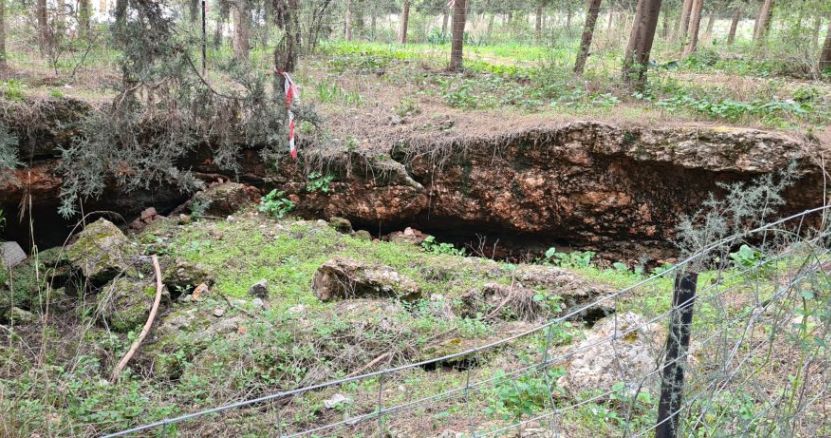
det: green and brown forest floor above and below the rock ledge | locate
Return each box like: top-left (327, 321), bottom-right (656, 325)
top-left (0, 39), bottom-right (831, 437)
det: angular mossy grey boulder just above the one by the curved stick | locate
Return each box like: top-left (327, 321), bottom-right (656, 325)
top-left (66, 218), bottom-right (137, 287)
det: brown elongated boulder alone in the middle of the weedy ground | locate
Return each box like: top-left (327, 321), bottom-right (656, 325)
top-left (312, 259), bottom-right (422, 301)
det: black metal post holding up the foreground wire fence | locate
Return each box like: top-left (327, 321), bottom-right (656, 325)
top-left (655, 272), bottom-right (698, 438)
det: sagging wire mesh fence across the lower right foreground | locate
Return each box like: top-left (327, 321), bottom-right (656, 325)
top-left (101, 206), bottom-right (831, 437)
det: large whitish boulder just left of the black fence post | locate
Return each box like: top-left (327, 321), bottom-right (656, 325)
top-left (557, 313), bottom-right (666, 397)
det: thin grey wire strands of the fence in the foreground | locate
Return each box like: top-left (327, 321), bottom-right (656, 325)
top-left (106, 206), bottom-right (831, 437)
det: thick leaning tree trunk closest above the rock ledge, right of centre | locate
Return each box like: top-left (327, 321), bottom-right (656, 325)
top-left (623, 0), bottom-right (661, 90)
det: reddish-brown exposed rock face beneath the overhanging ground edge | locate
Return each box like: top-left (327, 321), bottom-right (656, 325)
top-left (0, 102), bottom-right (822, 261)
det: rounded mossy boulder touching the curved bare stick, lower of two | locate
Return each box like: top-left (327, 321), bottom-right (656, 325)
top-left (96, 277), bottom-right (170, 333)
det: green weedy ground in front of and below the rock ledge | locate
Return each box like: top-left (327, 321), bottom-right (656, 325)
top-left (0, 212), bottom-right (831, 436)
